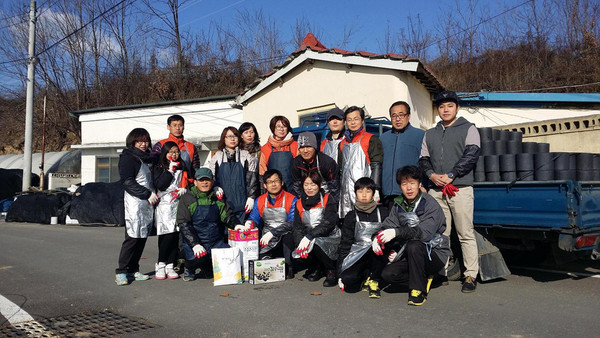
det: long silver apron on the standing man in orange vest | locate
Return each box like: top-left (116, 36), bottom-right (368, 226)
top-left (339, 134), bottom-right (371, 218)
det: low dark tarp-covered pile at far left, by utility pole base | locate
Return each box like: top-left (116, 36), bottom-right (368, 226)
top-left (6, 191), bottom-right (71, 224)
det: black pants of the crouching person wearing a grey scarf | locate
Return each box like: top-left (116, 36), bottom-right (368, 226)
top-left (340, 250), bottom-right (387, 291)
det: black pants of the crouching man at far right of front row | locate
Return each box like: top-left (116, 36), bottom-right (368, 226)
top-left (381, 241), bottom-right (444, 292)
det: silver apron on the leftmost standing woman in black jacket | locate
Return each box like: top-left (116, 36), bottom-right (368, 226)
top-left (123, 160), bottom-right (154, 238)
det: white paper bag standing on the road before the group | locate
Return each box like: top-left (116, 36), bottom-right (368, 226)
top-left (211, 248), bottom-right (242, 286)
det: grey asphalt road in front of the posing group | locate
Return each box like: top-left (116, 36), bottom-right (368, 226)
top-left (0, 222), bottom-right (600, 337)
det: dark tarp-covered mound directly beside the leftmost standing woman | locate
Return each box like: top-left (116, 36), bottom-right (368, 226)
top-left (69, 182), bottom-right (125, 225)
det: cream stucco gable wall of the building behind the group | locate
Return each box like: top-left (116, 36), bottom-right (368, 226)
top-left (243, 61), bottom-right (431, 138)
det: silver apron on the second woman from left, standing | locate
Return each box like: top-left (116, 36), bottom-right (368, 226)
top-left (154, 170), bottom-right (183, 235)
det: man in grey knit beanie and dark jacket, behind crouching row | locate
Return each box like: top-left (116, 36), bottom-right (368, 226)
top-left (290, 131), bottom-right (339, 200)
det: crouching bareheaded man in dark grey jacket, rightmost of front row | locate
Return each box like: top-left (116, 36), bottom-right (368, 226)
top-left (380, 166), bottom-right (450, 305)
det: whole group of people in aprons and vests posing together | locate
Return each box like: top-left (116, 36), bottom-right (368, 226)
top-left (116, 91), bottom-right (480, 305)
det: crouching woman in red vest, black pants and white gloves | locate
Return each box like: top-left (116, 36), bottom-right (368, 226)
top-left (292, 170), bottom-right (342, 287)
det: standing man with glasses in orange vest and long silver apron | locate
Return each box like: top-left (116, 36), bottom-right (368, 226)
top-left (339, 106), bottom-right (383, 218)
